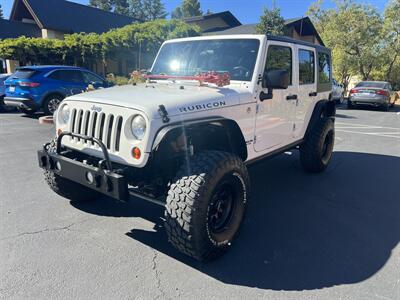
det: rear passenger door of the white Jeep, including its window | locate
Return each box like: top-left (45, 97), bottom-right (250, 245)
top-left (293, 45), bottom-right (318, 139)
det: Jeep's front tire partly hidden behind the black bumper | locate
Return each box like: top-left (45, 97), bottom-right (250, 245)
top-left (44, 141), bottom-right (102, 202)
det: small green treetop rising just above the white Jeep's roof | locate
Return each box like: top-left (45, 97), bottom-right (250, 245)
top-left (256, 6), bottom-right (285, 35)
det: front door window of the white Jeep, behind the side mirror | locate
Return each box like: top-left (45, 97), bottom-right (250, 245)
top-left (264, 45), bottom-right (292, 85)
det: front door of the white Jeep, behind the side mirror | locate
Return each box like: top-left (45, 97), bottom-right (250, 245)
top-left (254, 41), bottom-right (297, 152)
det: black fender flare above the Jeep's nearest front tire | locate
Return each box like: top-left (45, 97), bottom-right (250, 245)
top-left (151, 117), bottom-right (247, 161)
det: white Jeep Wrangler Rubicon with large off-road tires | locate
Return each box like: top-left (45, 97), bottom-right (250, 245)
top-left (38, 35), bottom-right (335, 261)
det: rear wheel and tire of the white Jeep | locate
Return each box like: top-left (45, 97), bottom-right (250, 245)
top-left (300, 117), bottom-right (335, 173)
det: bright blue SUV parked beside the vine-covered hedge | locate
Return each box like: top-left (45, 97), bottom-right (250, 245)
top-left (4, 66), bottom-right (109, 114)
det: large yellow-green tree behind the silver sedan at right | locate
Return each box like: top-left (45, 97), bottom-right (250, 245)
top-left (308, 0), bottom-right (383, 85)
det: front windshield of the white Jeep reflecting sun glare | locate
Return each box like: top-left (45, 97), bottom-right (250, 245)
top-left (151, 39), bottom-right (260, 81)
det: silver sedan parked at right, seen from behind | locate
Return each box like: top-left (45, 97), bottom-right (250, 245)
top-left (347, 81), bottom-right (396, 111)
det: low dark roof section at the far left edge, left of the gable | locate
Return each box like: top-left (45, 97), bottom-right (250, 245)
top-left (0, 19), bottom-right (42, 39)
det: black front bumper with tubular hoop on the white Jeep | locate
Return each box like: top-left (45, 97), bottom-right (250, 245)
top-left (38, 132), bottom-right (129, 201)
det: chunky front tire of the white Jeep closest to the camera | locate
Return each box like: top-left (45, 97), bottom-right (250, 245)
top-left (165, 151), bottom-right (250, 261)
